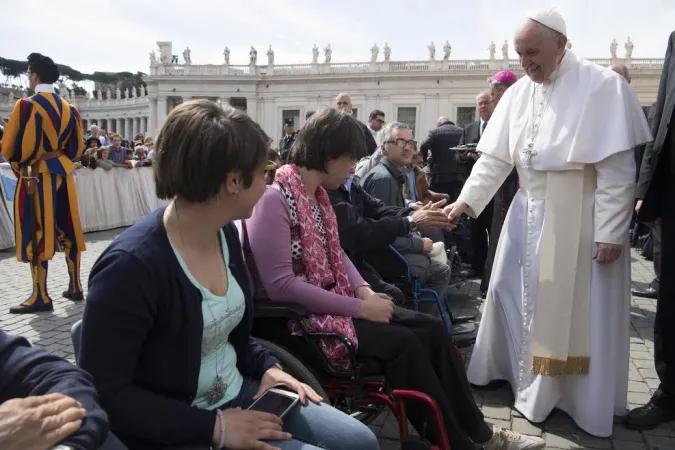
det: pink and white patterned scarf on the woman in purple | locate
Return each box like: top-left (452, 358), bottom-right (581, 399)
top-left (272, 164), bottom-right (358, 369)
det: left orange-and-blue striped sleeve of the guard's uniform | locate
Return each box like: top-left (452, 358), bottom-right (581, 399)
top-left (2, 98), bottom-right (42, 168)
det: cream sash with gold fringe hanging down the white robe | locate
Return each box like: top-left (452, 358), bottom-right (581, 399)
top-left (532, 167), bottom-right (594, 377)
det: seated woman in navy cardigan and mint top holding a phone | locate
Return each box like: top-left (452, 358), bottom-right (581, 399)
top-left (79, 100), bottom-right (379, 450)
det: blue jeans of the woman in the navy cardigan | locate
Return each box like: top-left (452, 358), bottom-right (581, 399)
top-left (227, 379), bottom-right (380, 450)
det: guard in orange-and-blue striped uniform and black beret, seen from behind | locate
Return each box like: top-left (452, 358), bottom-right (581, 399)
top-left (2, 53), bottom-right (85, 314)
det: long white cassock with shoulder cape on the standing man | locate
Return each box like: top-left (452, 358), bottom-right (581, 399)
top-left (458, 50), bottom-right (651, 437)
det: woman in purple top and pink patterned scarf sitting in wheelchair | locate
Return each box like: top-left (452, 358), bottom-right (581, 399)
top-left (246, 109), bottom-right (544, 450)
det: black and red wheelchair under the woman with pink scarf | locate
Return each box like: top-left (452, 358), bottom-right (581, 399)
top-left (252, 300), bottom-right (463, 450)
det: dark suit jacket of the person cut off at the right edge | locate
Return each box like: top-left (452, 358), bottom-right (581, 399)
top-left (636, 31), bottom-right (675, 222)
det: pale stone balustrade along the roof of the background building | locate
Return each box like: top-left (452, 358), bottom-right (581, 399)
top-left (150, 58), bottom-right (663, 77)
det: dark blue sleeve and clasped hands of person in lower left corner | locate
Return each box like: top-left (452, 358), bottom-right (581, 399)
top-left (0, 331), bottom-right (108, 450)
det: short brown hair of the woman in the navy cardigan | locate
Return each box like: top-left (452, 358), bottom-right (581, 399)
top-left (153, 100), bottom-right (268, 203)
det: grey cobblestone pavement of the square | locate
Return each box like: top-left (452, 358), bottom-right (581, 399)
top-left (0, 230), bottom-right (675, 450)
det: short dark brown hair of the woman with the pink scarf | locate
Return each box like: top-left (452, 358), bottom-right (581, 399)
top-left (288, 108), bottom-right (366, 172)
